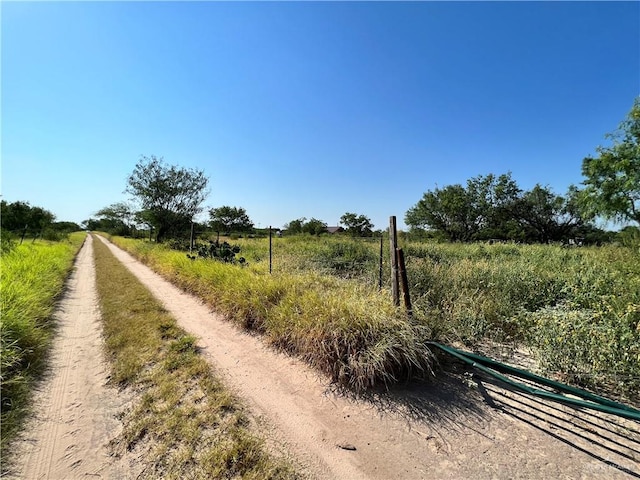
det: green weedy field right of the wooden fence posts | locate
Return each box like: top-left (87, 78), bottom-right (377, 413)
top-left (407, 243), bottom-right (640, 403)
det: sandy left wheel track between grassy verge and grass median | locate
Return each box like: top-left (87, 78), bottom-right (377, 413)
top-left (8, 236), bottom-right (127, 480)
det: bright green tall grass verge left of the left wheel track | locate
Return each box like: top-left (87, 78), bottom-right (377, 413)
top-left (0, 233), bottom-right (85, 448)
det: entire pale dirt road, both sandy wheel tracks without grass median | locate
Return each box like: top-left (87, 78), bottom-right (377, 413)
top-left (6, 237), bottom-right (640, 479)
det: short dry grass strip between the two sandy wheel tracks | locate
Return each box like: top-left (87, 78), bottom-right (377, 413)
top-left (94, 239), bottom-right (295, 479)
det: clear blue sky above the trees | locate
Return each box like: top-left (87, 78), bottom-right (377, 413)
top-left (1, 1), bottom-right (640, 228)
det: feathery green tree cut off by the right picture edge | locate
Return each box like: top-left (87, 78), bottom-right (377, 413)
top-left (581, 97), bottom-right (640, 225)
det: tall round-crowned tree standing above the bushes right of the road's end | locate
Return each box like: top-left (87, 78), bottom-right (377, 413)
top-left (125, 155), bottom-right (209, 242)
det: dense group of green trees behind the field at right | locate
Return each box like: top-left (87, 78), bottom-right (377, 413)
top-left (405, 99), bottom-right (640, 242)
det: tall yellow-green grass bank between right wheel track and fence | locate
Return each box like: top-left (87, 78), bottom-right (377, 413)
top-left (113, 237), bottom-right (433, 390)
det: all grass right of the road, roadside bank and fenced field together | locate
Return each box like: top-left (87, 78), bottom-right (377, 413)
top-left (110, 236), bottom-right (640, 402)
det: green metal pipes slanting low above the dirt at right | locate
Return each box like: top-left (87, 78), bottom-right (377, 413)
top-left (427, 342), bottom-right (640, 421)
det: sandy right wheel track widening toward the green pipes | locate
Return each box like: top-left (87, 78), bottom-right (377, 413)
top-left (95, 238), bottom-right (640, 479)
